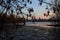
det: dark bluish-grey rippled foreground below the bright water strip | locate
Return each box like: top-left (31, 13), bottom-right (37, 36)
top-left (0, 24), bottom-right (60, 40)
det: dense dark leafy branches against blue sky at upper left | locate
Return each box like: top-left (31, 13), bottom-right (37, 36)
top-left (0, 0), bottom-right (32, 12)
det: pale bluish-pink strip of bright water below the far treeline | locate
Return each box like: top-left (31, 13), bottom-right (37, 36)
top-left (26, 22), bottom-right (54, 28)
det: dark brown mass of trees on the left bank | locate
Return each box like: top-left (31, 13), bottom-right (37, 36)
top-left (0, 13), bottom-right (25, 23)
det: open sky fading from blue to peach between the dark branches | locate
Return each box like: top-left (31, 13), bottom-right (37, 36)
top-left (23, 0), bottom-right (54, 19)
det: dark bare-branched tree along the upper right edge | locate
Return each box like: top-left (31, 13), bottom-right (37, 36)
top-left (39, 0), bottom-right (60, 18)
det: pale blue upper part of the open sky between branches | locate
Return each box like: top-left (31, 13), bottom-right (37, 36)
top-left (23, 0), bottom-right (51, 14)
